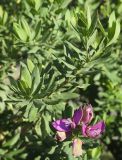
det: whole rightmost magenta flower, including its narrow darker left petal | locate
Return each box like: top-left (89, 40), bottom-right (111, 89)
top-left (82, 121), bottom-right (105, 138)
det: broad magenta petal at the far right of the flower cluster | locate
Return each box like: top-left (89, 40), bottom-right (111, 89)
top-left (86, 121), bottom-right (105, 138)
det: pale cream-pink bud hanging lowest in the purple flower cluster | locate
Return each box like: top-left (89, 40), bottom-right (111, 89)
top-left (72, 139), bottom-right (82, 157)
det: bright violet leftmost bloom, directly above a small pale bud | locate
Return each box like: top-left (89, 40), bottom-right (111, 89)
top-left (52, 119), bottom-right (72, 132)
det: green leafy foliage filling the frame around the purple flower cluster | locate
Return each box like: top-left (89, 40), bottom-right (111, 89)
top-left (0, 0), bottom-right (122, 160)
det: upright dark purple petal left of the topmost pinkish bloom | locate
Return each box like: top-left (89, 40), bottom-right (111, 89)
top-left (72, 107), bottom-right (82, 125)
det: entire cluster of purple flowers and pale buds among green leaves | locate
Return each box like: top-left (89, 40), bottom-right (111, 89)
top-left (52, 104), bottom-right (105, 157)
